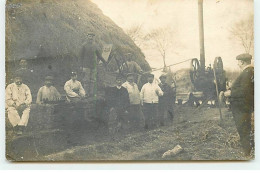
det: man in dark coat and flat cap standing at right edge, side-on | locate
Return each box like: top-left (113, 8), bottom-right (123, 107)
top-left (231, 54), bottom-right (254, 156)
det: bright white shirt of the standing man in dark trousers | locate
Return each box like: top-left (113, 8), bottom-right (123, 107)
top-left (140, 82), bottom-right (163, 103)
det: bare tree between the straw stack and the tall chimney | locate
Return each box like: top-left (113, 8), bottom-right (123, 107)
top-left (145, 27), bottom-right (173, 69)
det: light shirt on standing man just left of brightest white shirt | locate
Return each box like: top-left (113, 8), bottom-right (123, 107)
top-left (122, 81), bottom-right (141, 105)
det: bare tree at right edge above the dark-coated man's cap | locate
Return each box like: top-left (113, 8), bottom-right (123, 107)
top-left (230, 15), bottom-right (254, 53)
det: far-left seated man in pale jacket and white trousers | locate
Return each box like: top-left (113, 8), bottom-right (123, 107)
top-left (5, 74), bottom-right (32, 135)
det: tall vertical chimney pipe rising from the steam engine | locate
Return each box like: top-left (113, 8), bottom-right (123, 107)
top-left (198, 0), bottom-right (205, 73)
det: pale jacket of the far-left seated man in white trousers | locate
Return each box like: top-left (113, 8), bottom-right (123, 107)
top-left (5, 83), bottom-right (32, 107)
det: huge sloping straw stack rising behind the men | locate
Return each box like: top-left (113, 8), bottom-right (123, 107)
top-left (6, 0), bottom-right (150, 70)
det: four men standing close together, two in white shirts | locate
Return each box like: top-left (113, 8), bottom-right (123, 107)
top-left (105, 73), bottom-right (175, 132)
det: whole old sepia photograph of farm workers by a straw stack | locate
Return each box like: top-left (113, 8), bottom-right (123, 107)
top-left (5, 0), bottom-right (255, 163)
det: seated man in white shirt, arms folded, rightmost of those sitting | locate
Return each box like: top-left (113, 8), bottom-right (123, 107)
top-left (64, 72), bottom-right (86, 102)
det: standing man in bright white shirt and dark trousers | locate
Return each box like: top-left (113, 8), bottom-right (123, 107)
top-left (140, 74), bottom-right (163, 129)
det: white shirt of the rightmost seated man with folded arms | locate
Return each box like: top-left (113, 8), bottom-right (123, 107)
top-left (64, 79), bottom-right (86, 97)
